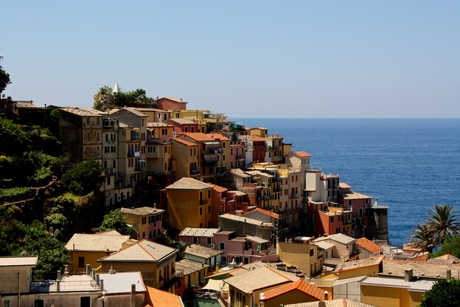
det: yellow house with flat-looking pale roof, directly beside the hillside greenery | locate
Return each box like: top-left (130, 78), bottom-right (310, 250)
top-left (65, 230), bottom-right (129, 274)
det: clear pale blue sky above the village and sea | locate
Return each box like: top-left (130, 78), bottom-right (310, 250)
top-left (0, 0), bottom-right (460, 118)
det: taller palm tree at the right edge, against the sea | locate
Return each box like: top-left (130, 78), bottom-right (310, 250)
top-left (426, 205), bottom-right (459, 245)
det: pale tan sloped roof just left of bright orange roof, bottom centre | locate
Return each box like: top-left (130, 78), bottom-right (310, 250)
top-left (224, 266), bottom-right (291, 293)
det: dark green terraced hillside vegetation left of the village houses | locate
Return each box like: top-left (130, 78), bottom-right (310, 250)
top-left (0, 116), bottom-right (105, 280)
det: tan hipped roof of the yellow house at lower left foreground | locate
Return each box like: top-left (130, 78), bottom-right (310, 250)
top-left (98, 239), bottom-right (178, 262)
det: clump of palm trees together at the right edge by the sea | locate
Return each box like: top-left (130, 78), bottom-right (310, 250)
top-left (410, 205), bottom-right (459, 253)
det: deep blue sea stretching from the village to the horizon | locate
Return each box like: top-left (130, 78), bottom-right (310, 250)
top-left (234, 118), bottom-right (460, 246)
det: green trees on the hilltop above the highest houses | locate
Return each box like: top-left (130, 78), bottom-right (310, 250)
top-left (93, 85), bottom-right (156, 111)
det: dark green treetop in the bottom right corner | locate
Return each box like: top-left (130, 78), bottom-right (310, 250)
top-left (420, 279), bottom-right (460, 307)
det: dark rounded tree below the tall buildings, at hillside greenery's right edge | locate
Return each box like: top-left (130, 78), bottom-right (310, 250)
top-left (61, 159), bottom-right (104, 196)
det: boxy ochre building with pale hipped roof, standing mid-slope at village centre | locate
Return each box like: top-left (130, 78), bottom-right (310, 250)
top-left (166, 177), bottom-right (217, 232)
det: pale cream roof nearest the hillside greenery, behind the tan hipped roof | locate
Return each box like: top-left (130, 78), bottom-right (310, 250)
top-left (65, 231), bottom-right (129, 252)
